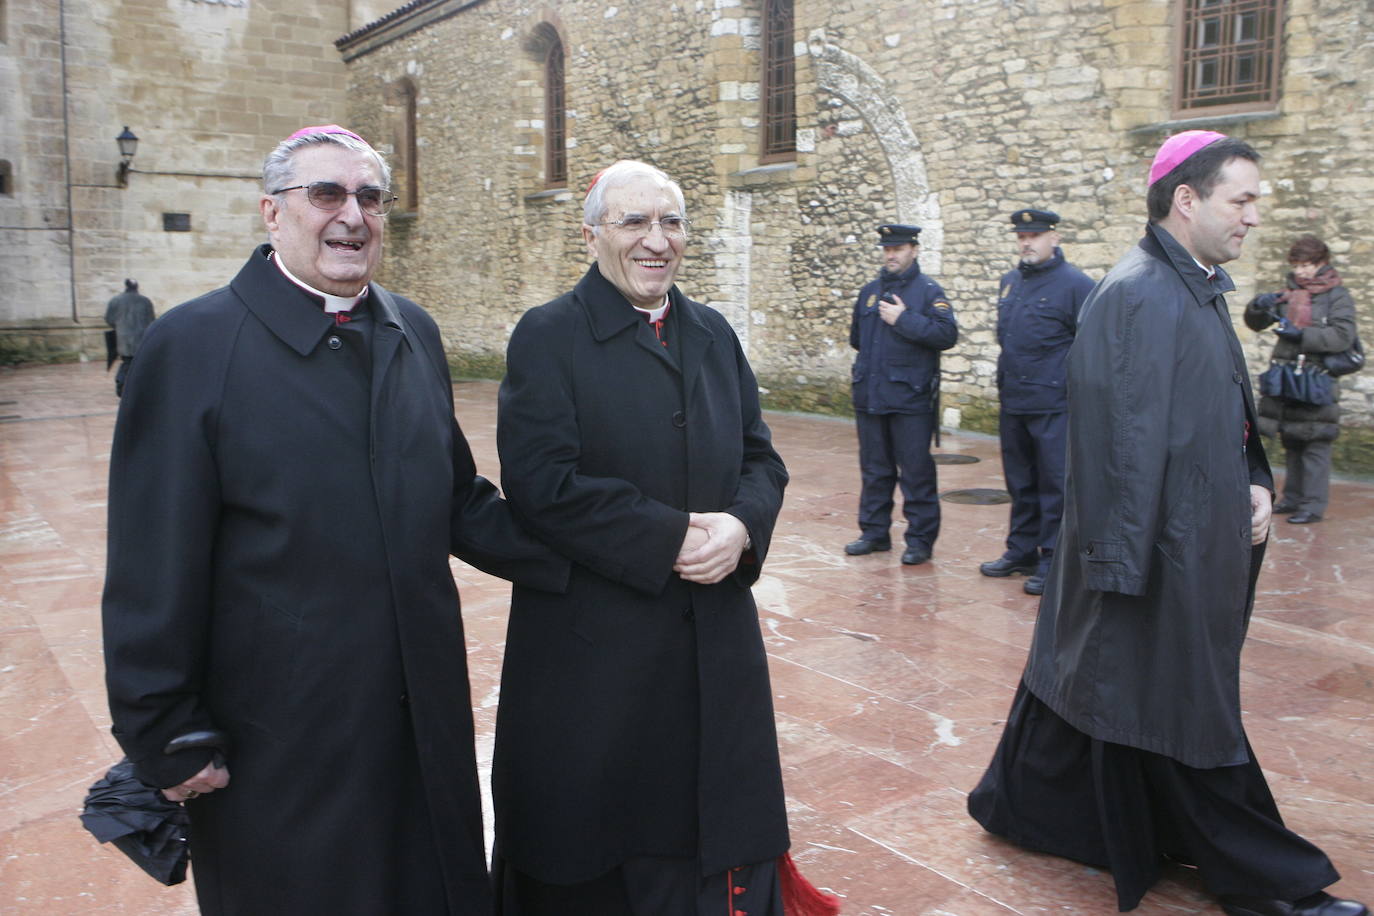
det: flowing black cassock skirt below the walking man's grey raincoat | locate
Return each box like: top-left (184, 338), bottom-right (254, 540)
top-left (969, 683), bottom-right (1340, 912)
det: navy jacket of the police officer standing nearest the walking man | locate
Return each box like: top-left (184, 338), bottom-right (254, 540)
top-left (998, 249), bottom-right (1092, 413)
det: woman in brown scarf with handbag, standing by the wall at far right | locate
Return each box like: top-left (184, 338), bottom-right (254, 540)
top-left (1245, 235), bottom-right (1358, 525)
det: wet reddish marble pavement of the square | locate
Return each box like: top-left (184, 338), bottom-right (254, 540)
top-left (0, 364), bottom-right (1374, 916)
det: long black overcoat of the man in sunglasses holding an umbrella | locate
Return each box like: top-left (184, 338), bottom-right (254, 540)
top-left (104, 246), bottom-right (566, 916)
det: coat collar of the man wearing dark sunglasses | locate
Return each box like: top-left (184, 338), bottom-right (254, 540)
top-left (229, 244), bottom-right (409, 356)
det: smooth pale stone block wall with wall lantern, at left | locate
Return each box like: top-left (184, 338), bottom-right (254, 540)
top-left (0, 0), bottom-right (362, 361)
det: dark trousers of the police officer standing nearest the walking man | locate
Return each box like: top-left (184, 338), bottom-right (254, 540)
top-left (998, 412), bottom-right (1069, 573)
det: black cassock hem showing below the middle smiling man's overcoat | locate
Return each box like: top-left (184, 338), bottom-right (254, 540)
top-left (492, 854), bottom-right (783, 916)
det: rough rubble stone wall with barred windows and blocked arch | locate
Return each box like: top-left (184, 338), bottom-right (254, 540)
top-left (341, 0), bottom-right (1374, 472)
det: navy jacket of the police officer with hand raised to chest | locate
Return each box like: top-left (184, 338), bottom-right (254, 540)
top-left (849, 262), bottom-right (959, 413)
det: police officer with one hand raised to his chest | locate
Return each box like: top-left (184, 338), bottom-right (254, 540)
top-left (845, 222), bottom-right (959, 566)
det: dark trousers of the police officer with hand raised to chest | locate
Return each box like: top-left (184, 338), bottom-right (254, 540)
top-left (855, 412), bottom-right (940, 551)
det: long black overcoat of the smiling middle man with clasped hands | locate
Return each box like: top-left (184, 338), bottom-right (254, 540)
top-left (492, 265), bottom-right (787, 883)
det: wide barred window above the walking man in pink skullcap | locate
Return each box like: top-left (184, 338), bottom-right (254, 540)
top-left (1175, 0), bottom-right (1283, 114)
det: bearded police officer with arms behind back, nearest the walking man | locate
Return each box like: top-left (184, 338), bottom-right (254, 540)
top-left (978, 210), bottom-right (1092, 595)
